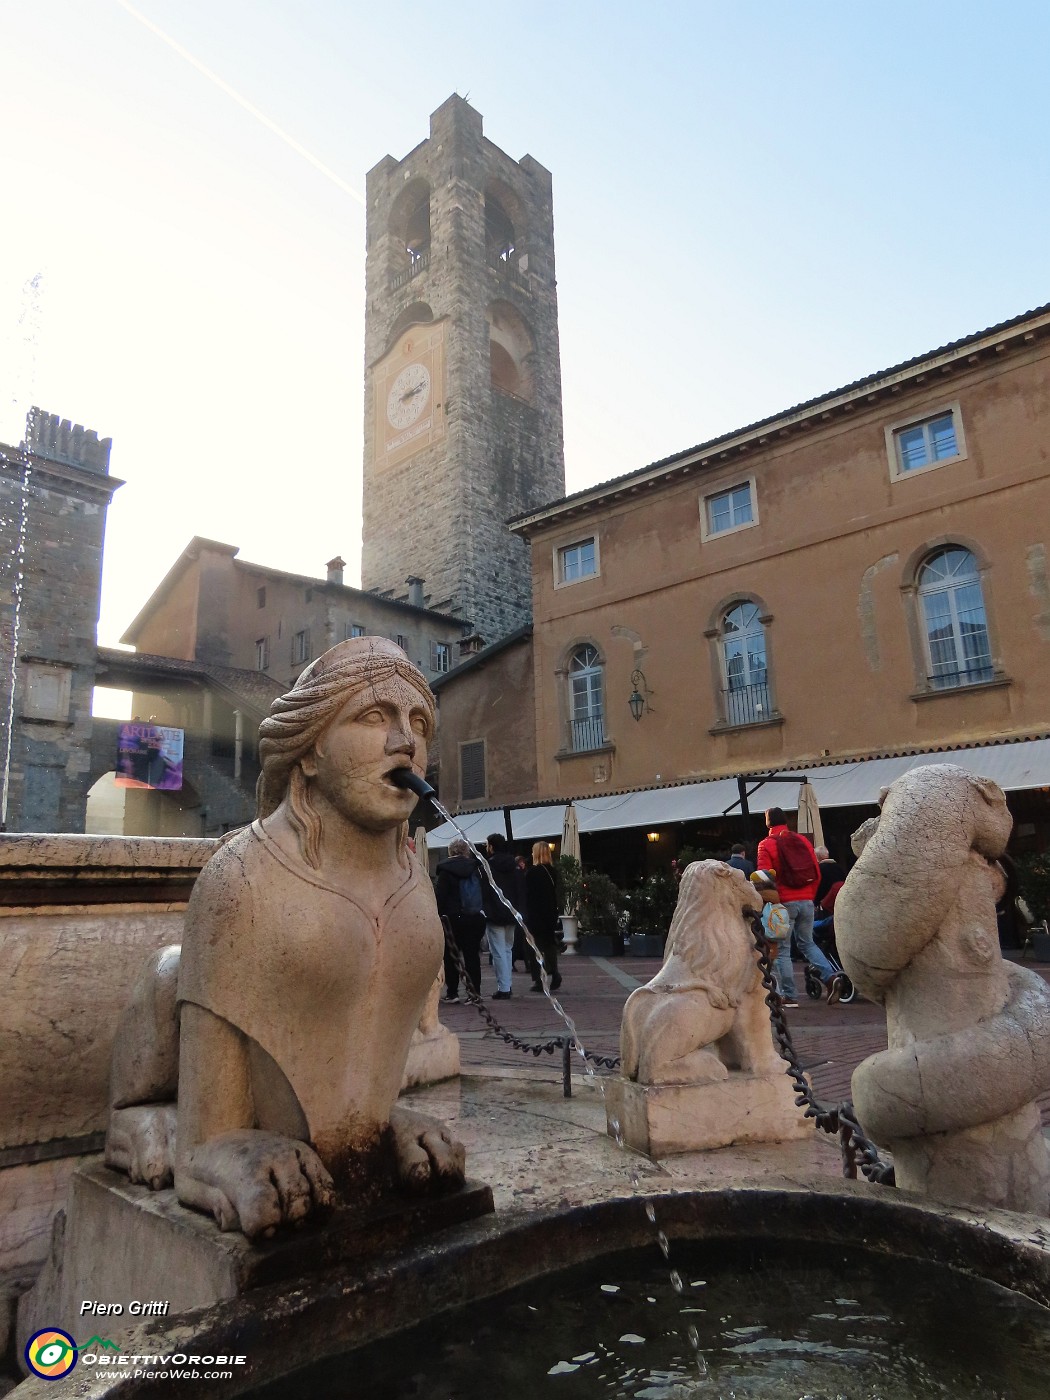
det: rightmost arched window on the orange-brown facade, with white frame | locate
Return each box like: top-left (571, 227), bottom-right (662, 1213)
top-left (918, 545), bottom-right (994, 690)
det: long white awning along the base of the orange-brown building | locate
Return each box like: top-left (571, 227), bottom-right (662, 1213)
top-left (427, 739), bottom-right (1050, 847)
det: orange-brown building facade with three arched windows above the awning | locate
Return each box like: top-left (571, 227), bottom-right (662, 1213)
top-left (506, 308), bottom-right (1050, 804)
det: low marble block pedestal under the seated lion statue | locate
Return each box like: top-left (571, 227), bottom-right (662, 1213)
top-left (605, 1071), bottom-right (815, 1158)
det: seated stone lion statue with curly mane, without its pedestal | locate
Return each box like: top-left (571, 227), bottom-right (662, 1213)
top-left (620, 861), bottom-right (783, 1084)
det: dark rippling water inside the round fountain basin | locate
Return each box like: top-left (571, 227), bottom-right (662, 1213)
top-left (253, 1240), bottom-right (1050, 1400)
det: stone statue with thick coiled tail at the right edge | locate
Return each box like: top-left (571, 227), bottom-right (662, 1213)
top-left (834, 763), bottom-right (1050, 1214)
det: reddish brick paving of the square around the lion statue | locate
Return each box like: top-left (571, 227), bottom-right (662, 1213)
top-left (441, 956), bottom-right (1050, 1128)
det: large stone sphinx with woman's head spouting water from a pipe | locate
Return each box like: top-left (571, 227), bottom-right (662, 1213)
top-left (106, 637), bottom-right (463, 1236)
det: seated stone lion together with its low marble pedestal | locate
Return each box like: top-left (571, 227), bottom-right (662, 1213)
top-left (606, 861), bottom-right (812, 1156)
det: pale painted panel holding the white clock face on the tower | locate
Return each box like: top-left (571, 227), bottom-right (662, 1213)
top-left (372, 321), bottom-right (445, 469)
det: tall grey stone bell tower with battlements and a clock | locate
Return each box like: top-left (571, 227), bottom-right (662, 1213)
top-left (361, 97), bottom-right (566, 643)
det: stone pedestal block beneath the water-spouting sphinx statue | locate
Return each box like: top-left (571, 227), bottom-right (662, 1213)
top-left (17, 1163), bottom-right (493, 1357)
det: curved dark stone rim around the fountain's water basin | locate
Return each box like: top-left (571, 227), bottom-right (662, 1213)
top-left (18, 1180), bottom-right (1050, 1400)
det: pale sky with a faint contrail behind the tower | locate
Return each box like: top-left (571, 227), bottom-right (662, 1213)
top-left (0, 0), bottom-right (1050, 641)
